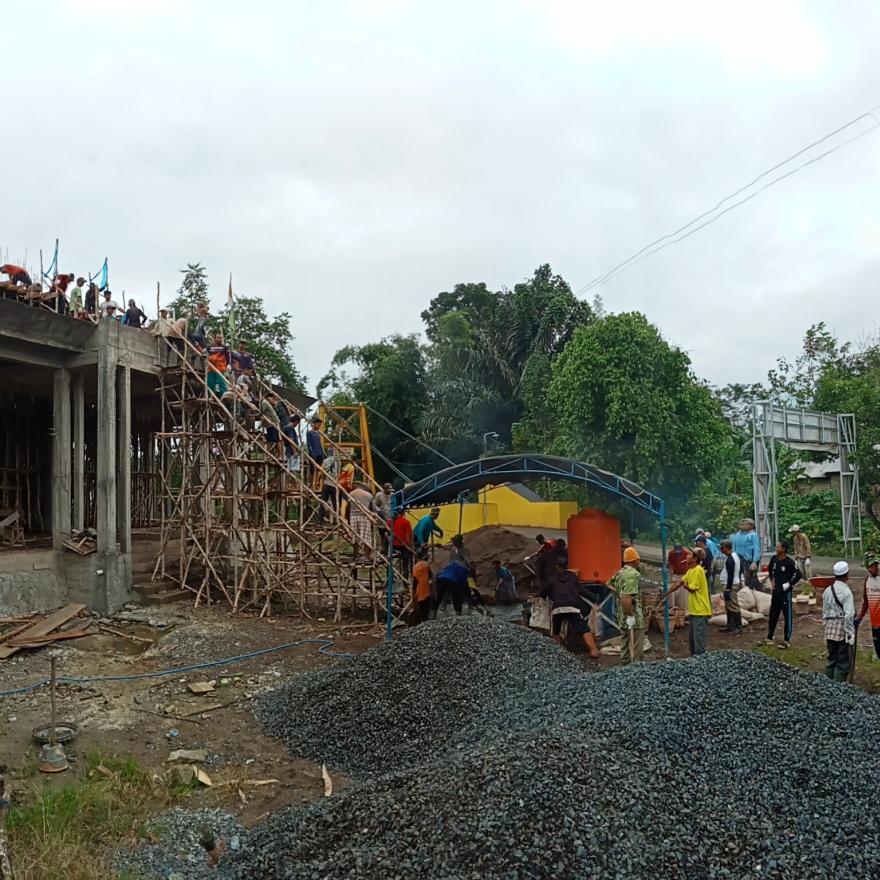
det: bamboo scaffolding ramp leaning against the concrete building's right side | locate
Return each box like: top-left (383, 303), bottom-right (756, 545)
top-left (153, 340), bottom-right (411, 623)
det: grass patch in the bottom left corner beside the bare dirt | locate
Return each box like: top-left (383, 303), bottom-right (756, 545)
top-left (6, 752), bottom-right (190, 880)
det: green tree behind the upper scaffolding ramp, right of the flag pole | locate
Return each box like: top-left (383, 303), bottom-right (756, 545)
top-left (218, 296), bottom-right (306, 391)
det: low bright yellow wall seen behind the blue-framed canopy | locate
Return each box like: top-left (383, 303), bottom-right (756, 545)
top-left (409, 483), bottom-right (578, 538)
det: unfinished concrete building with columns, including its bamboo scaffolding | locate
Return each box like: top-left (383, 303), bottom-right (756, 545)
top-left (0, 300), bottom-right (392, 617)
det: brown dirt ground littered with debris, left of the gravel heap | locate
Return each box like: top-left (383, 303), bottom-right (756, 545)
top-left (0, 606), bottom-right (384, 821)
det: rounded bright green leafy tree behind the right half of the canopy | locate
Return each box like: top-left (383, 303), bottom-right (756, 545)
top-left (548, 312), bottom-right (735, 498)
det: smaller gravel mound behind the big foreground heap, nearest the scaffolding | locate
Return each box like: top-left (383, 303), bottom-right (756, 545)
top-left (254, 615), bottom-right (581, 774)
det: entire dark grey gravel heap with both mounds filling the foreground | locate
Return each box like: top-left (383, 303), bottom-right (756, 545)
top-left (131, 618), bottom-right (880, 880)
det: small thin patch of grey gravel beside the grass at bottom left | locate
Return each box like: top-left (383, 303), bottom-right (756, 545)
top-left (114, 807), bottom-right (246, 880)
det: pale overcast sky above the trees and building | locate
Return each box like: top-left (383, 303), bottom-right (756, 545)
top-left (0, 0), bottom-right (880, 386)
